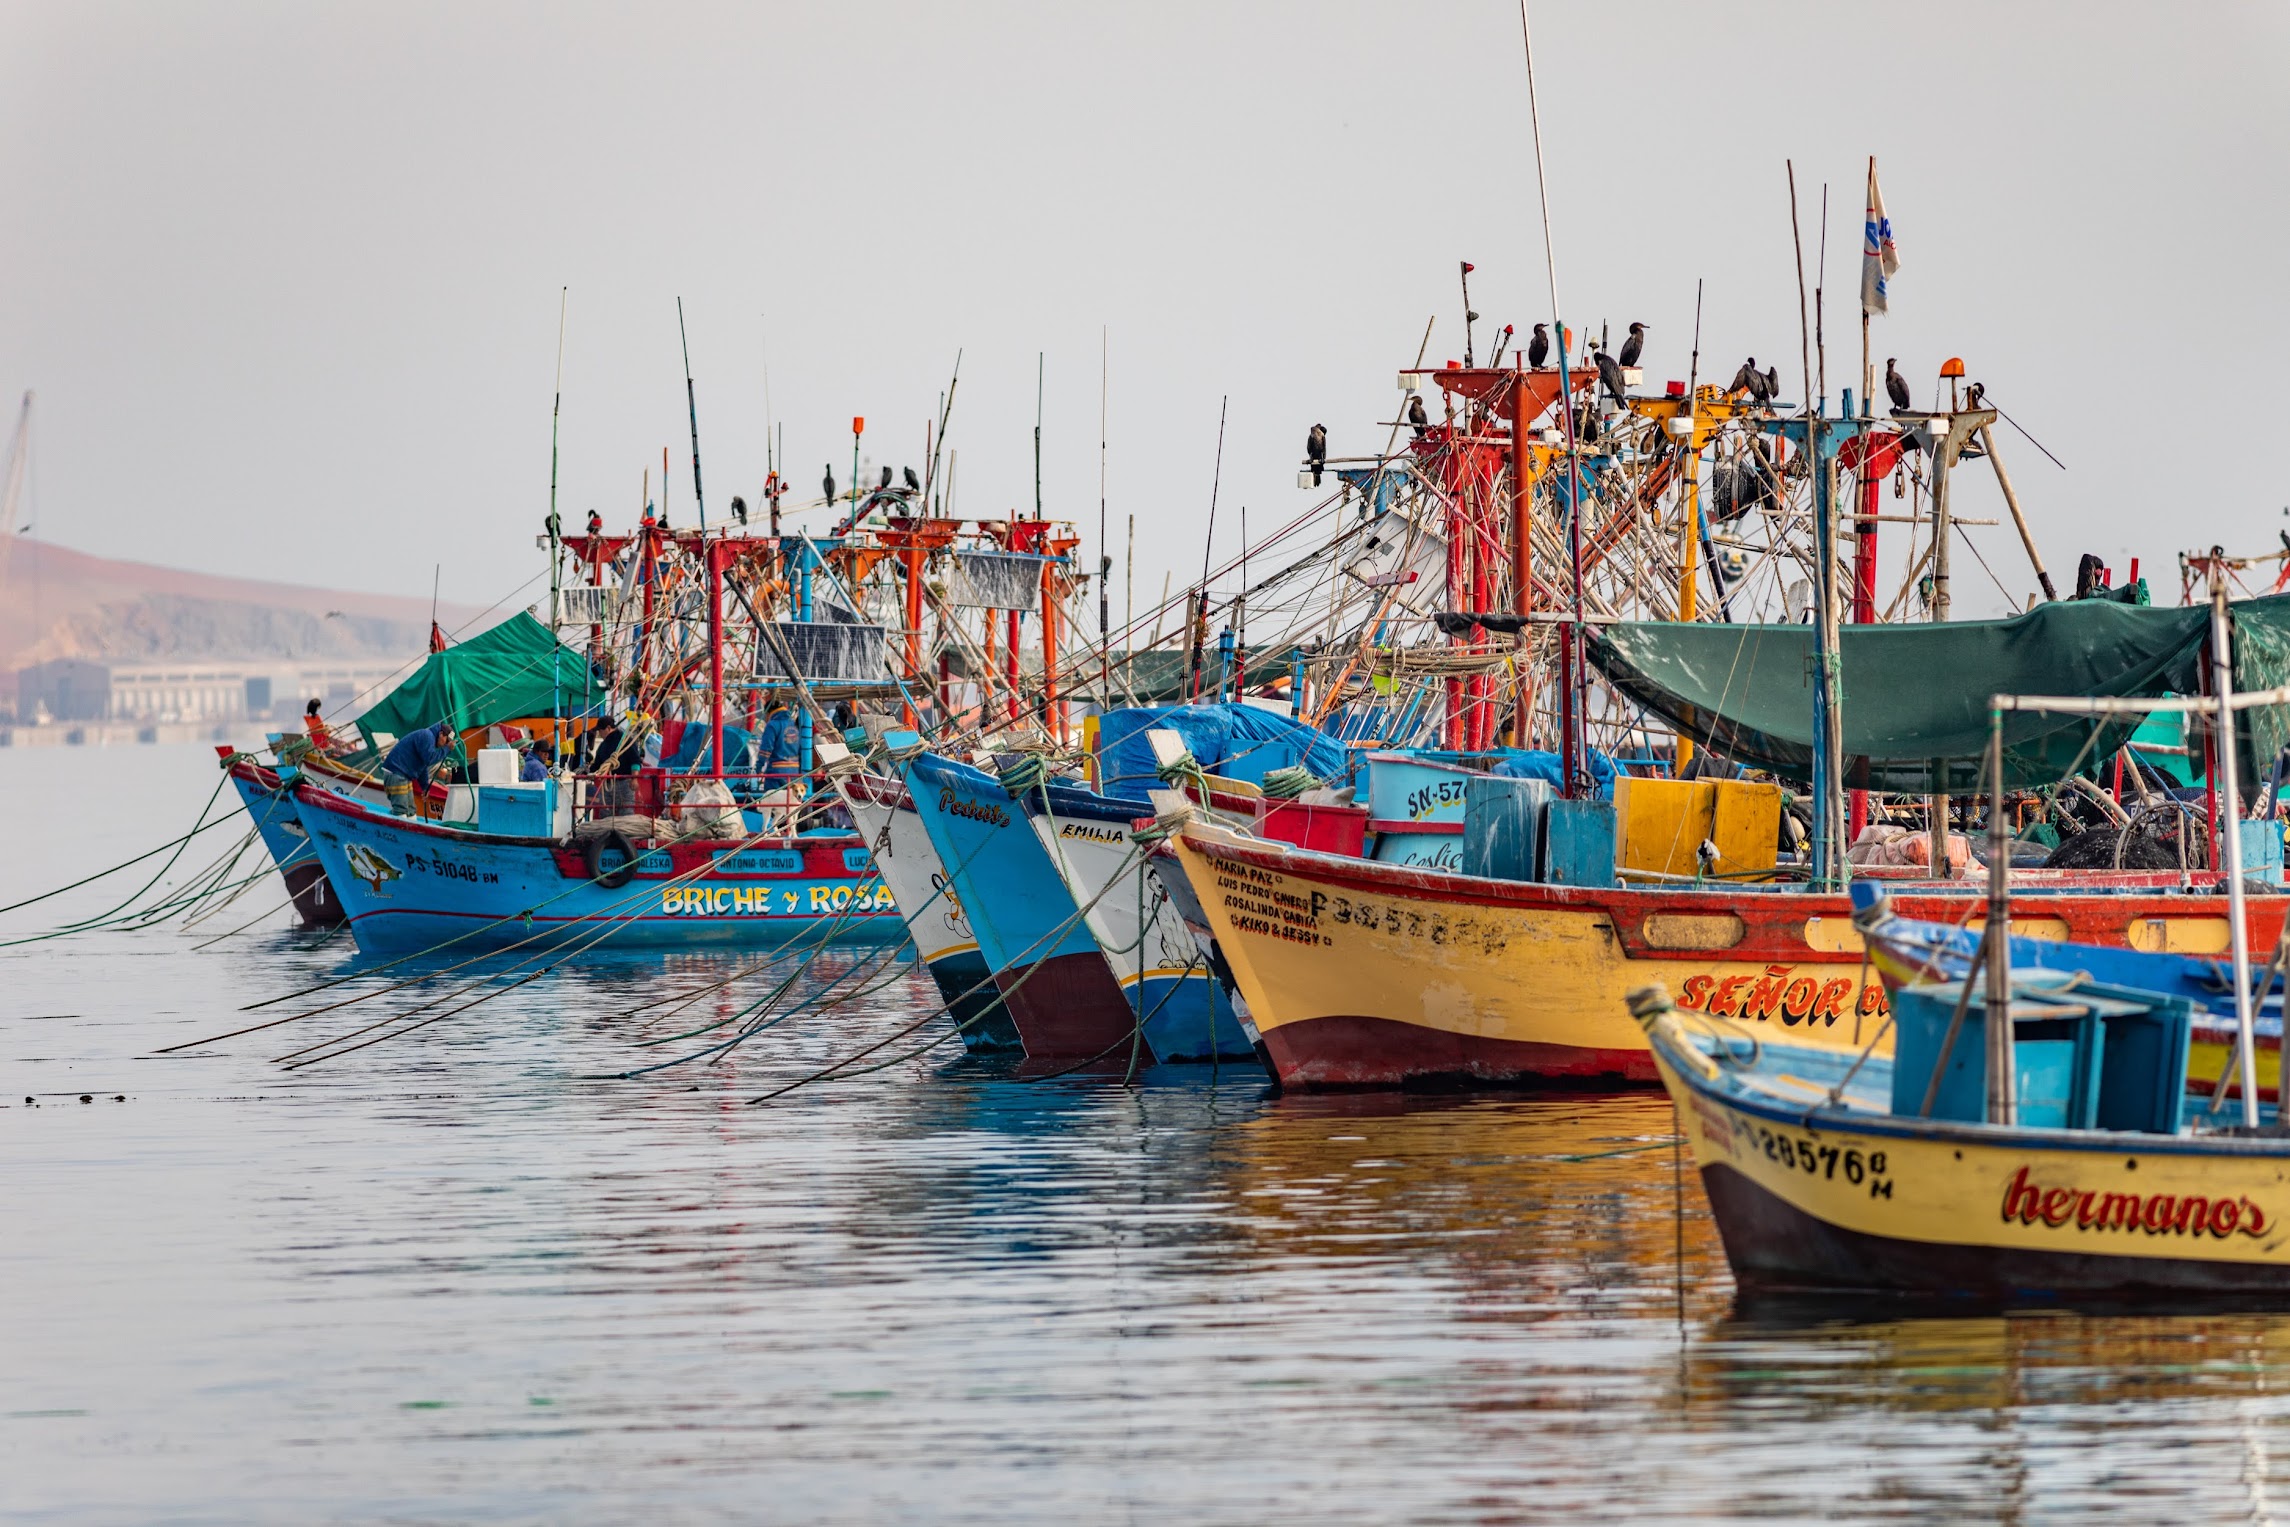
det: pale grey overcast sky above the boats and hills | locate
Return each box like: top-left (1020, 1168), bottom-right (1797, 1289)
top-left (0, 0), bottom-right (2290, 614)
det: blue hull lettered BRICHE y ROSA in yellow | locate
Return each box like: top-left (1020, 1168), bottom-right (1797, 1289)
top-left (293, 781), bottom-right (907, 952)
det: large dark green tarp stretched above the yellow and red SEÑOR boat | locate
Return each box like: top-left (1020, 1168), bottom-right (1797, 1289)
top-left (1589, 598), bottom-right (2290, 794)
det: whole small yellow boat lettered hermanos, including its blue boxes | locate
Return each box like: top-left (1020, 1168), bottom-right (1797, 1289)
top-left (1630, 973), bottom-right (2290, 1298)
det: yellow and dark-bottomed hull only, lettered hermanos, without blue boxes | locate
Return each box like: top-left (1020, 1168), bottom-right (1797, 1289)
top-left (1653, 1014), bottom-right (2290, 1298)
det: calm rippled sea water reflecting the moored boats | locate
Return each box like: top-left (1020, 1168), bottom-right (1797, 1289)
top-left (0, 749), bottom-right (2290, 1522)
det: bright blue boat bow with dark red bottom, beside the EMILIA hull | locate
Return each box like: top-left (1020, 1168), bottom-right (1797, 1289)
top-left (905, 753), bottom-right (1152, 1062)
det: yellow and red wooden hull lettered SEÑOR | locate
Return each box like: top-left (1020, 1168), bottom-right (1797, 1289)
top-left (1172, 822), bottom-right (2283, 1087)
